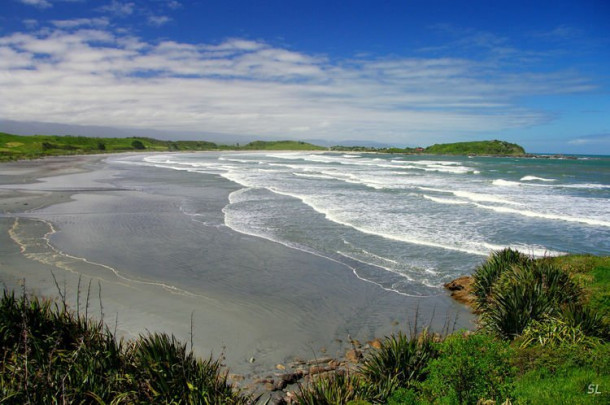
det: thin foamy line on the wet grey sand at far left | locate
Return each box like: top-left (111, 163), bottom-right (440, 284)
top-left (8, 217), bottom-right (212, 300)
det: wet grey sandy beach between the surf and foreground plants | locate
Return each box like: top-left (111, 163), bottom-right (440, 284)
top-left (0, 155), bottom-right (472, 378)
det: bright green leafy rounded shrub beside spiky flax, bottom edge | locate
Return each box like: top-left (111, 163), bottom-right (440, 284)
top-left (422, 333), bottom-right (514, 404)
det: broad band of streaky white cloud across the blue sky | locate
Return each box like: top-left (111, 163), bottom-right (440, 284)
top-left (0, 27), bottom-right (590, 143)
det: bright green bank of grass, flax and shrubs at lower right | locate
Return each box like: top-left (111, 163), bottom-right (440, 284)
top-left (292, 251), bottom-right (610, 405)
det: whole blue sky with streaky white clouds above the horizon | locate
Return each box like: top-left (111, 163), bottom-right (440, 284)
top-left (0, 0), bottom-right (610, 155)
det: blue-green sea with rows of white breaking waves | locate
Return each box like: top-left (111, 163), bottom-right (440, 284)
top-left (115, 152), bottom-right (610, 296)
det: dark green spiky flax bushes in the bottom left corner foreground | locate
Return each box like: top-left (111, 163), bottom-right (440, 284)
top-left (0, 291), bottom-right (248, 404)
